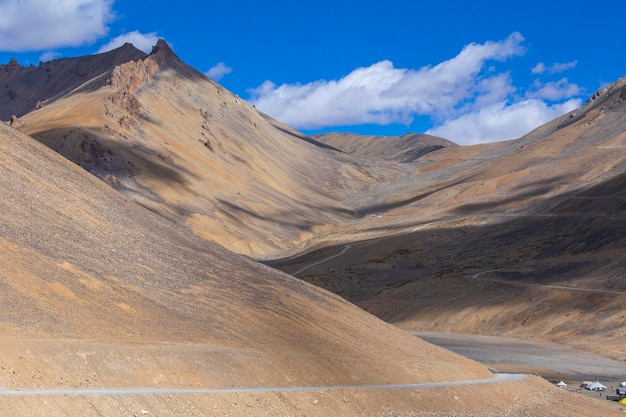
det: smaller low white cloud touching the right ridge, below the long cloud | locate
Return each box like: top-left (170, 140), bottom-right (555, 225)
top-left (426, 99), bottom-right (582, 145)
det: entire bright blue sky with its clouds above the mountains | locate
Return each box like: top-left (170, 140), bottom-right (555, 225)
top-left (0, 0), bottom-right (626, 144)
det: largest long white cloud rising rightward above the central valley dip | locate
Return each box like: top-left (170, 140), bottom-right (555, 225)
top-left (251, 33), bottom-right (524, 129)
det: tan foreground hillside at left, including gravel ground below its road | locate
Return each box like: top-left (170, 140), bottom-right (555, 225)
top-left (0, 115), bottom-right (618, 416)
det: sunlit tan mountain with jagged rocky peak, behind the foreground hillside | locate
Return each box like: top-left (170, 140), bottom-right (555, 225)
top-left (14, 41), bottom-right (410, 258)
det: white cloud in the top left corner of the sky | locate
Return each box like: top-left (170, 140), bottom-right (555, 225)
top-left (0, 0), bottom-right (114, 52)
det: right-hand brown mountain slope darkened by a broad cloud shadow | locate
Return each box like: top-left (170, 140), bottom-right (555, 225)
top-left (272, 78), bottom-right (626, 360)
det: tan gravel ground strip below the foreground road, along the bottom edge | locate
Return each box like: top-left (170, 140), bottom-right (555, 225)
top-left (0, 360), bottom-right (625, 417)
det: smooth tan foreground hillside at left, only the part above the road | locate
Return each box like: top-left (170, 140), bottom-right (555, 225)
top-left (0, 121), bottom-right (502, 404)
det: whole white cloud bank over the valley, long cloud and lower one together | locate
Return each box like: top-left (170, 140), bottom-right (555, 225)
top-left (250, 32), bottom-right (580, 144)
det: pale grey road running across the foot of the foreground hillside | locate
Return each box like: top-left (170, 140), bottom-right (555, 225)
top-left (0, 374), bottom-right (524, 397)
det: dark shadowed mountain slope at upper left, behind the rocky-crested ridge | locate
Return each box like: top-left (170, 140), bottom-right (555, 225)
top-left (0, 43), bottom-right (146, 120)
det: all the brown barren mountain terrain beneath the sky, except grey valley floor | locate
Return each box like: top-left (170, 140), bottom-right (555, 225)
top-left (0, 41), bottom-right (626, 416)
